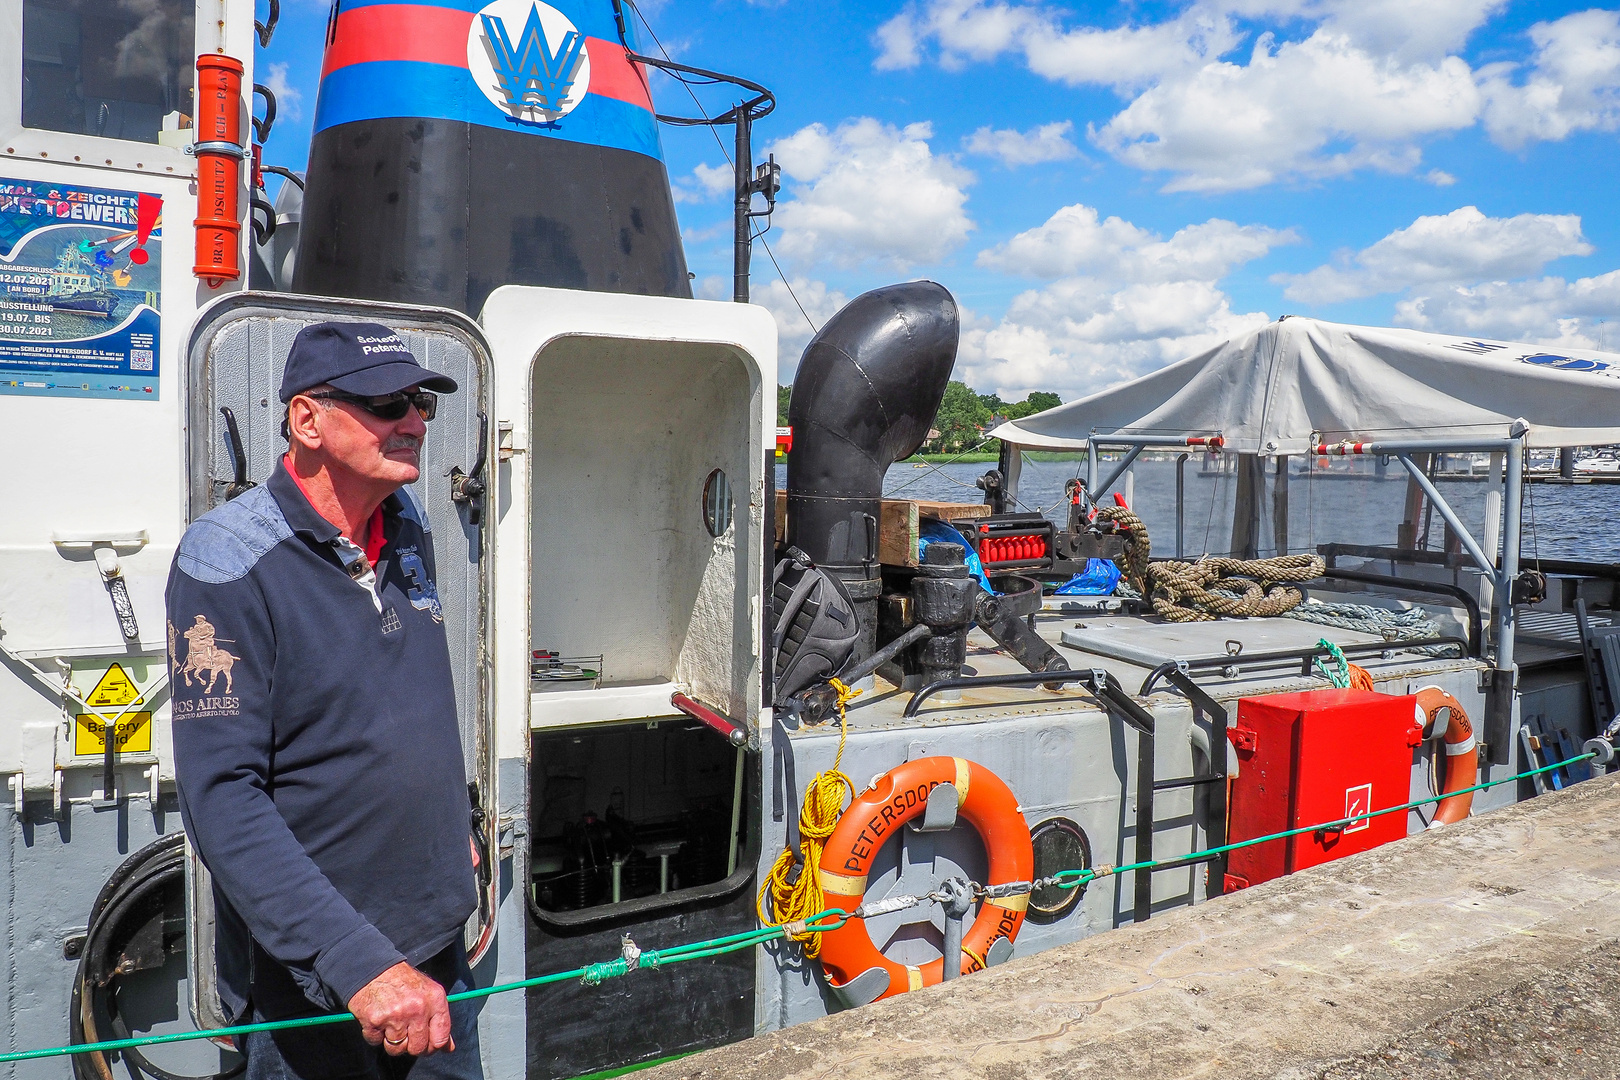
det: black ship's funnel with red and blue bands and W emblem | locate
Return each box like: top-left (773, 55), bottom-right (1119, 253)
top-left (293, 0), bottom-right (692, 316)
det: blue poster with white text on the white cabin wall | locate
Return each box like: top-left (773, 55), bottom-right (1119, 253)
top-left (0, 178), bottom-right (164, 402)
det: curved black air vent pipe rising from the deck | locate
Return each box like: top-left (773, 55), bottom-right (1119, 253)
top-left (787, 282), bottom-right (957, 662)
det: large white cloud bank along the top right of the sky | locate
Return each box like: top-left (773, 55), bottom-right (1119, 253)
top-left (875, 0), bottom-right (1620, 191)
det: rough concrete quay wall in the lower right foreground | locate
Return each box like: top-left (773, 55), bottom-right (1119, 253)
top-left (642, 779), bottom-right (1620, 1080)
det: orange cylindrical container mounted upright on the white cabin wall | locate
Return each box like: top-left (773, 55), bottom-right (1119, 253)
top-left (191, 53), bottom-right (243, 288)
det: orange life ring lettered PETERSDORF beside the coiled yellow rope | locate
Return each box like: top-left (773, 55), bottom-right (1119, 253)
top-left (816, 758), bottom-right (1035, 999)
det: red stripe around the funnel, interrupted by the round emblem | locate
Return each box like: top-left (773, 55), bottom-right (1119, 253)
top-left (321, 3), bottom-right (653, 112)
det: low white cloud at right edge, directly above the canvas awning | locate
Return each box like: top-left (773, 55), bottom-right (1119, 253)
top-left (1395, 270), bottom-right (1620, 350)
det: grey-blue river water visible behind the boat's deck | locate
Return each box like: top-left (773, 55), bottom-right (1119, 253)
top-left (776, 455), bottom-right (1620, 562)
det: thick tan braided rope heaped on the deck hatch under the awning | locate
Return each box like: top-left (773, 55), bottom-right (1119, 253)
top-left (1147, 555), bottom-right (1327, 622)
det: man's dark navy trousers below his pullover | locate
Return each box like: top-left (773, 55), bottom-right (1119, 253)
top-left (241, 942), bottom-right (484, 1080)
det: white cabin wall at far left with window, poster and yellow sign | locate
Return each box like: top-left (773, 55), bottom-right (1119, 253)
top-left (0, 0), bottom-right (254, 806)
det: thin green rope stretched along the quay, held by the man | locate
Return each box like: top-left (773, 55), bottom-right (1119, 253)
top-left (0, 757), bottom-right (1594, 1065)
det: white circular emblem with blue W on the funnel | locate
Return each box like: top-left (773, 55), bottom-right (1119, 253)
top-left (467, 0), bottom-right (591, 123)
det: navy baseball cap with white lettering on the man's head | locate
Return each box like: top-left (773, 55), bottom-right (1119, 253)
top-left (280, 322), bottom-right (455, 403)
